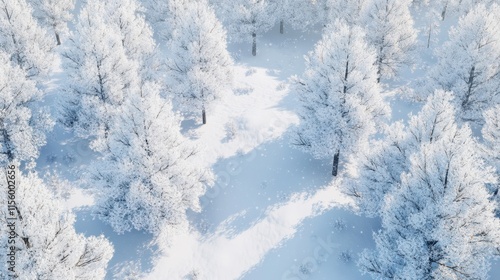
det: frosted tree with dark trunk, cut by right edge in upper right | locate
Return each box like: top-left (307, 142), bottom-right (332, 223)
top-left (427, 4), bottom-right (500, 123)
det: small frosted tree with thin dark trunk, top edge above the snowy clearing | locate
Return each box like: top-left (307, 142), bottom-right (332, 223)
top-left (220, 0), bottom-right (276, 56)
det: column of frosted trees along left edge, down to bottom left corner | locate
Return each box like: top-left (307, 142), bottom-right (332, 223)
top-left (0, 0), bottom-right (113, 279)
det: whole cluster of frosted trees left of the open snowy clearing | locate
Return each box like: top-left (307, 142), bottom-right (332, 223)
top-left (0, 0), bottom-right (233, 279)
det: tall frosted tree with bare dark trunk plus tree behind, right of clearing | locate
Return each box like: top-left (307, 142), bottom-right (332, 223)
top-left (293, 0), bottom-right (416, 176)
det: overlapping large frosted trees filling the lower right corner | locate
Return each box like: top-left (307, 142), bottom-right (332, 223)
top-left (350, 90), bottom-right (500, 279)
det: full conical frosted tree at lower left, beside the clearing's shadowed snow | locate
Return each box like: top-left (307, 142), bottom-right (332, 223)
top-left (89, 83), bottom-right (212, 234)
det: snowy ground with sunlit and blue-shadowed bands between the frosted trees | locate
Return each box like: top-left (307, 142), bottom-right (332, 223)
top-left (38, 17), bottom-right (500, 280)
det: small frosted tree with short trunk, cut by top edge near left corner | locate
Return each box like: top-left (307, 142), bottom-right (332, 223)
top-left (29, 0), bottom-right (75, 45)
